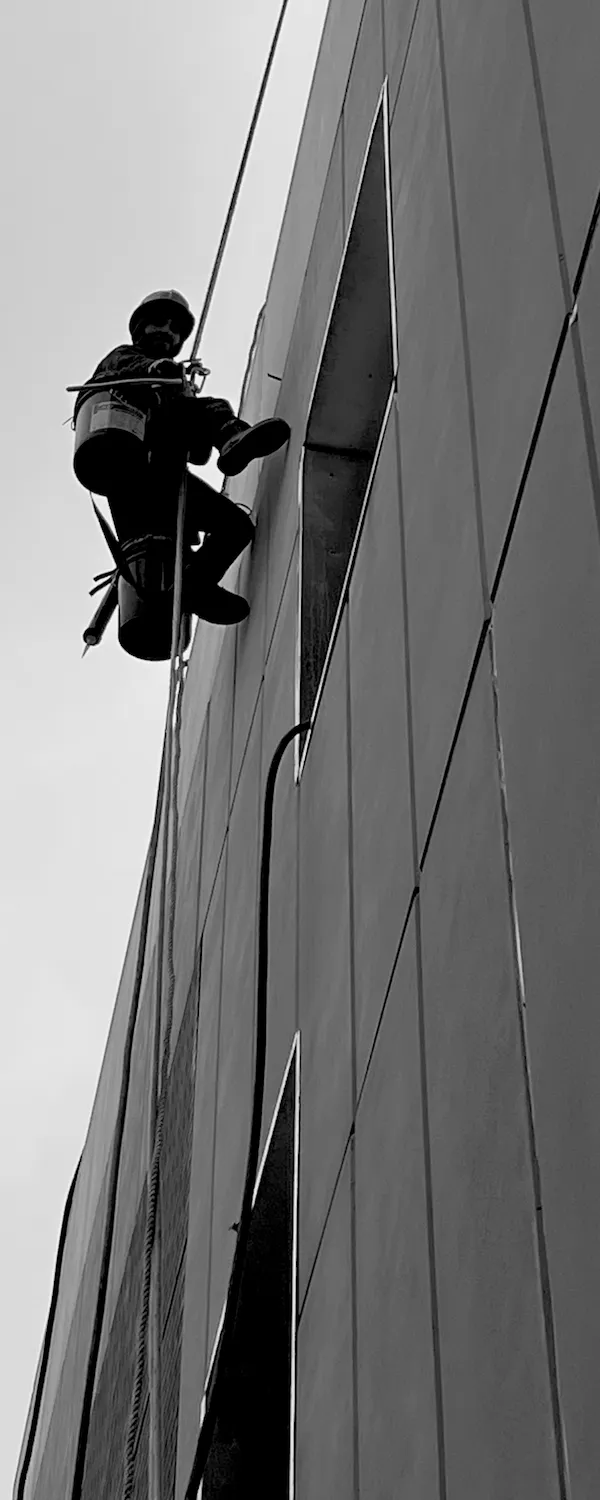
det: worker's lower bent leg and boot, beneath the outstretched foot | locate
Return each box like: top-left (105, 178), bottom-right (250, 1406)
top-left (185, 474), bottom-right (254, 624)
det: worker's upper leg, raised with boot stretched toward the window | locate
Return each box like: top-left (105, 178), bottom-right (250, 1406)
top-left (186, 396), bottom-right (290, 474)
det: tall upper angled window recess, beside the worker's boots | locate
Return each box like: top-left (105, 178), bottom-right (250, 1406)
top-left (297, 89), bottom-right (396, 758)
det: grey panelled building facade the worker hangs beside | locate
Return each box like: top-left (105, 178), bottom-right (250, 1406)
top-left (15, 0), bottom-right (600, 1500)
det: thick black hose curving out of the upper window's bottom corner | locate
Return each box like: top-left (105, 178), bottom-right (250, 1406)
top-left (185, 723), bottom-right (309, 1500)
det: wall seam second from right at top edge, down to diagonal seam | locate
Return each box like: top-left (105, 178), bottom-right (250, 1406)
top-left (435, 0), bottom-right (492, 620)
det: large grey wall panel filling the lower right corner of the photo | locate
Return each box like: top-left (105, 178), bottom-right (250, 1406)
top-left (497, 347), bottom-right (600, 1500)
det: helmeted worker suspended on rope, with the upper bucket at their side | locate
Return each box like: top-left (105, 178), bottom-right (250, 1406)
top-left (74, 291), bottom-right (290, 654)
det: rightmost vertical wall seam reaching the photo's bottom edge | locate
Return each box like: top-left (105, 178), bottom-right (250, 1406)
top-left (489, 623), bottom-right (570, 1500)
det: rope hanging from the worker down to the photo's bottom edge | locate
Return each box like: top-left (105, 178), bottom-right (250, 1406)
top-left (122, 477), bottom-right (186, 1500)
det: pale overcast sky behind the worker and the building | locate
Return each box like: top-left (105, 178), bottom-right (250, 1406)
top-left (0, 0), bottom-right (327, 1497)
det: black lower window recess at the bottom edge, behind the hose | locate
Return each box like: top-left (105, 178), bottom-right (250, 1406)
top-left (200, 1037), bottom-right (300, 1500)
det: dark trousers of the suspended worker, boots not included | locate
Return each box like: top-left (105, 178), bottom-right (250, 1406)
top-left (107, 396), bottom-right (254, 582)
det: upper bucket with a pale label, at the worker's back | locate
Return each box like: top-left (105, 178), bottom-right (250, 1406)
top-left (74, 390), bottom-right (147, 495)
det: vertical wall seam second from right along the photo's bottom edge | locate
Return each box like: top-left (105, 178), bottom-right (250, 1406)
top-left (414, 893), bottom-right (447, 1500)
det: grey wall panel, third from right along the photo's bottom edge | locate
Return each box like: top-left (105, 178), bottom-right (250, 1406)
top-left (356, 917), bottom-right (438, 1500)
